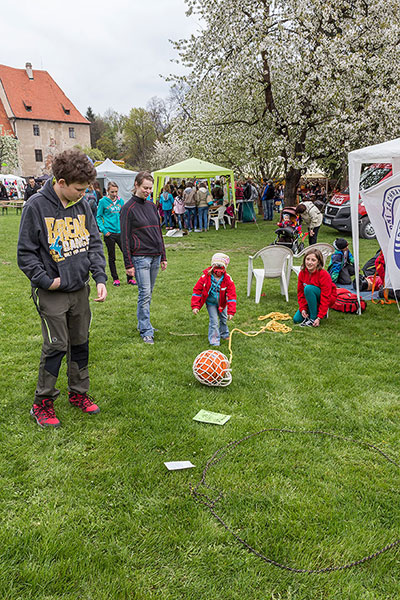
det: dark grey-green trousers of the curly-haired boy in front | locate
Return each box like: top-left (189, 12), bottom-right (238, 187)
top-left (32, 285), bottom-right (91, 402)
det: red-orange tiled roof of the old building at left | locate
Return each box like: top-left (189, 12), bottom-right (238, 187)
top-left (0, 65), bottom-right (89, 124)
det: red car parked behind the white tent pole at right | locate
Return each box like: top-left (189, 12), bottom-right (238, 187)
top-left (323, 163), bottom-right (392, 240)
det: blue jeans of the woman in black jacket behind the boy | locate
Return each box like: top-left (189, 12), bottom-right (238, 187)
top-left (132, 256), bottom-right (161, 337)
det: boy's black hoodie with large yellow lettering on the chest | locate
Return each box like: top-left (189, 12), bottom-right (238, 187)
top-left (18, 179), bottom-right (107, 292)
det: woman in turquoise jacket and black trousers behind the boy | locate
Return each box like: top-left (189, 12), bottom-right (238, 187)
top-left (96, 181), bottom-right (136, 287)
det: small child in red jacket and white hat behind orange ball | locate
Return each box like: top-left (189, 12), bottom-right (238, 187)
top-left (191, 252), bottom-right (236, 346)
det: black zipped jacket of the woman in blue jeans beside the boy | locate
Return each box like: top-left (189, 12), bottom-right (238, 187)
top-left (120, 196), bottom-right (165, 269)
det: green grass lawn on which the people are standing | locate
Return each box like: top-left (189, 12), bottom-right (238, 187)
top-left (0, 214), bottom-right (400, 600)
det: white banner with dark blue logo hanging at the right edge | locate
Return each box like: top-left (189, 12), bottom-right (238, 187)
top-left (361, 173), bottom-right (400, 290)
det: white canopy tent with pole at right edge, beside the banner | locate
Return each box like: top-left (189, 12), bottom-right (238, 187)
top-left (349, 138), bottom-right (400, 312)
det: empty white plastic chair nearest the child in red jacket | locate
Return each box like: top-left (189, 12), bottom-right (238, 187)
top-left (247, 246), bottom-right (293, 304)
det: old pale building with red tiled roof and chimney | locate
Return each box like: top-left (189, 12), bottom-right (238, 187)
top-left (0, 63), bottom-right (90, 177)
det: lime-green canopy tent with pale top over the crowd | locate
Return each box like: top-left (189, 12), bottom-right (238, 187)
top-left (153, 158), bottom-right (236, 210)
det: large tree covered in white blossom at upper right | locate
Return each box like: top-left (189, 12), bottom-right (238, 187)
top-left (172, 0), bottom-right (400, 202)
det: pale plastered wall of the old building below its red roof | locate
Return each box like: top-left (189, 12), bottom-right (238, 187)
top-left (14, 119), bottom-right (90, 177)
